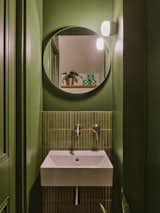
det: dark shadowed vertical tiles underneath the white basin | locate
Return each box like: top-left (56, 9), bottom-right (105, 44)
top-left (43, 187), bottom-right (111, 213)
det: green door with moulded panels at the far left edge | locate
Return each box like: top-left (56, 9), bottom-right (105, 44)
top-left (0, 0), bottom-right (16, 213)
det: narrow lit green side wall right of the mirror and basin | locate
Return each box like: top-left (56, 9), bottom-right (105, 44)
top-left (112, 0), bottom-right (123, 213)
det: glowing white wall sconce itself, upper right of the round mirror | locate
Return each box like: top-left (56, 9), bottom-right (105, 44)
top-left (101, 20), bottom-right (118, 37)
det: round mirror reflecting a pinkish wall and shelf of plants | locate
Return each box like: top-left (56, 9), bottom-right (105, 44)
top-left (43, 27), bottom-right (110, 94)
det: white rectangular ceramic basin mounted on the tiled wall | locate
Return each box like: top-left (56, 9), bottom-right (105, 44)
top-left (40, 151), bottom-right (113, 186)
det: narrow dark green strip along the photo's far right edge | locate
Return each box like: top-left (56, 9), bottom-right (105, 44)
top-left (145, 0), bottom-right (160, 213)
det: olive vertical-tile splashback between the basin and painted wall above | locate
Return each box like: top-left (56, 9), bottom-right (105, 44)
top-left (43, 111), bottom-right (112, 156)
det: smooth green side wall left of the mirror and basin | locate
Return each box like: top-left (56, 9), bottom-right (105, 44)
top-left (26, 0), bottom-right (42, 213)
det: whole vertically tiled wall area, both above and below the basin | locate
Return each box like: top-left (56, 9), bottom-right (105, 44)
top-left (43, 111), bottom-right (112, 213)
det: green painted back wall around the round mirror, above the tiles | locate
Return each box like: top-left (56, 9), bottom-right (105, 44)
top-left (43, 0), bottom-right (113, 110)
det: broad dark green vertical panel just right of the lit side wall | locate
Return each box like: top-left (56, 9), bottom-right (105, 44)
top-left (123, 0), bottom-right (146, 213)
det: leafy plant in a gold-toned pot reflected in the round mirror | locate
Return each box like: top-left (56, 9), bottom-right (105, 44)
top-left (62, 70), bottom-right (82, 86)
